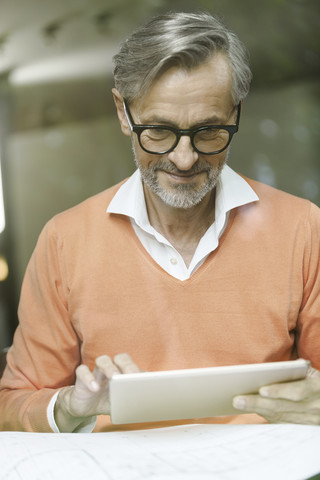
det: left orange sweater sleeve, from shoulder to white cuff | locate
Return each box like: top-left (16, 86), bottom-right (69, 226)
top-left (0, 220), bottom-right (80, 432)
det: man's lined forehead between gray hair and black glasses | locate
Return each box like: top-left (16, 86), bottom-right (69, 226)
top-left (133, 54), bottom-right (233, 125)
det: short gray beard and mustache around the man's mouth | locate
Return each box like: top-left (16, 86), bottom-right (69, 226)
top-left (134, 152), bottom-right (228, 209)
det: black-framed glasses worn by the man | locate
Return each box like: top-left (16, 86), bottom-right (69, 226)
top-left (123, 100), bottom-right (241, 155)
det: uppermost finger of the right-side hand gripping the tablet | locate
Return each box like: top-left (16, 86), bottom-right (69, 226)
top-left (259, 368), bottom-right (320, 402)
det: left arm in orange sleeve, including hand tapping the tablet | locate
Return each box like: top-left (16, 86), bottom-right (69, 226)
top-left (0, 215), bottom-right (139, 432)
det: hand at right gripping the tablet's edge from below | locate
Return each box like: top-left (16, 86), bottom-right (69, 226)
top-left (233, 367), bottom-right (320, 425)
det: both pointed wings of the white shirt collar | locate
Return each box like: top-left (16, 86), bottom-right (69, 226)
top-left (107, 165), bottom-right (259, 233)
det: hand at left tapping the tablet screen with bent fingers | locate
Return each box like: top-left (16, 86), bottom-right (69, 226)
top-left (54, 353), bottom-right (140, 432)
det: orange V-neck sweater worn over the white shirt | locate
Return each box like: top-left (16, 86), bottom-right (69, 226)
top-left (0, 176), bottom-right (320, 431)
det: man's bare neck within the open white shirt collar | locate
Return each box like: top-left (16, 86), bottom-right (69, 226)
top-left (144, 185), bottom-right (215, 266)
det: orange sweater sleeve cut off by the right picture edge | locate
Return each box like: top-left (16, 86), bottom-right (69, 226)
top-left (297, 204), bottom-right (320, 370)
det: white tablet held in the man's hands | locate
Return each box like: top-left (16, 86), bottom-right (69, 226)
top-left (110, 359), bottom-right (309, 424)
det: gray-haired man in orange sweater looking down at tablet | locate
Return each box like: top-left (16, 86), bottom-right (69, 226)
top-left (0, 13), bottom-right (320, 432)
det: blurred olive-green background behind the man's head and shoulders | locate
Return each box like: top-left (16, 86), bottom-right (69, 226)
top-left (0, 0), bottom-right (320, 348)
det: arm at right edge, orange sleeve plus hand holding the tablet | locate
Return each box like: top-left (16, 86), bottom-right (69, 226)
top-left (234, 204), bottom-right (320, 425)
